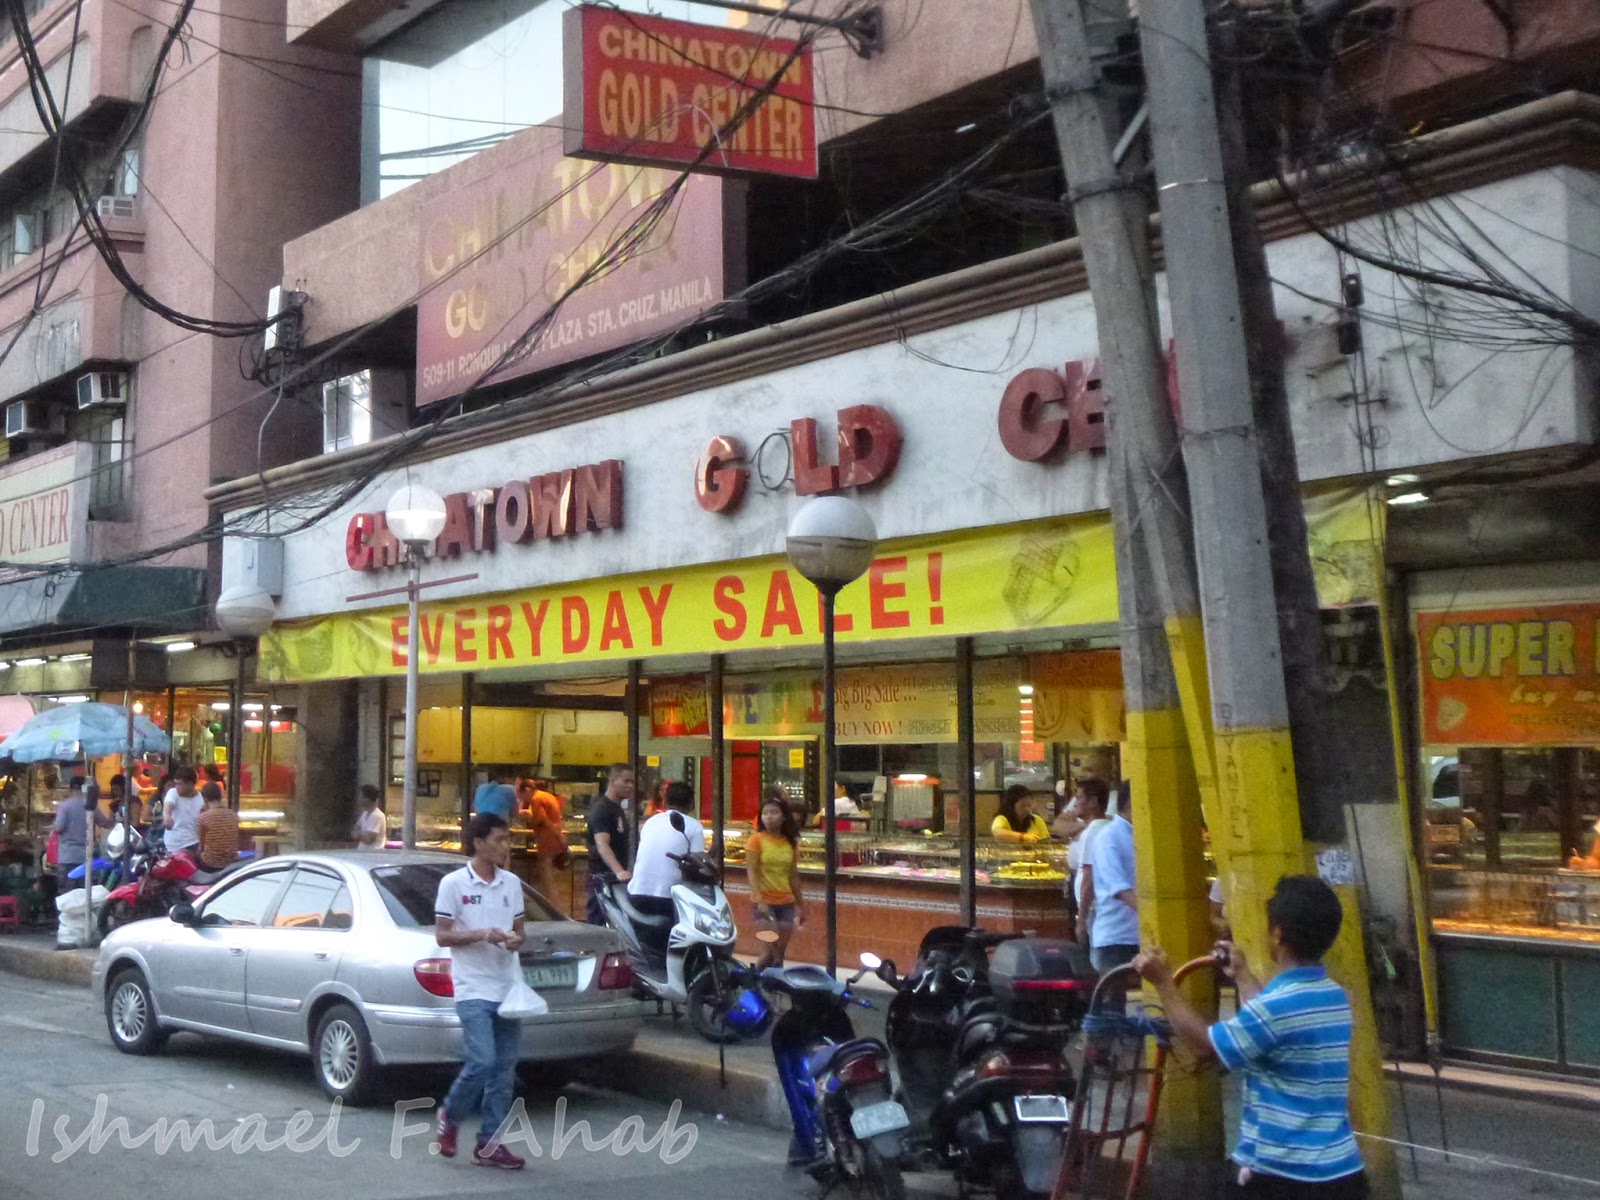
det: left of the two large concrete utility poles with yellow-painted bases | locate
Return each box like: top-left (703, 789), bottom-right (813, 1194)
top-left (1032, 0), bottom-right (1224, 1197)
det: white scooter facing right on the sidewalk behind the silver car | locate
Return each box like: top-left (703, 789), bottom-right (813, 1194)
top-left (600, 813), bottom-right (773, 1043)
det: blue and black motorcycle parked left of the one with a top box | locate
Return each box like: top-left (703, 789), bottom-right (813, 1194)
top-left (760, 955), bottom-right (909, 1200)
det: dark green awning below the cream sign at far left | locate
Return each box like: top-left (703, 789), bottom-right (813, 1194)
top-left (0, 566), bottom-right (208, 637)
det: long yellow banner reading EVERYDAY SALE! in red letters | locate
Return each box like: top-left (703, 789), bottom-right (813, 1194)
top-left (259, 514), bottom-right (1117, 682)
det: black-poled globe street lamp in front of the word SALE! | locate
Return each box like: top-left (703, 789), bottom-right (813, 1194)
top-left (786, 496), bottom-right (878, 974)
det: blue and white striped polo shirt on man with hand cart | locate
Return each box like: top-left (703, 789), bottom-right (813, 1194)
top-left (1211, 966), bottom-right (1362, 1182)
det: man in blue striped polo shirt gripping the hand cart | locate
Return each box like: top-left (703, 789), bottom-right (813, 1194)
top-left (1134, 875), bottom-right (1368, 1200)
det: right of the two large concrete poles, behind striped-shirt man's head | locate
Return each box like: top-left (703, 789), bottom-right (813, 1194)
top-left (1139, 0), bottom-right (1400, 1197)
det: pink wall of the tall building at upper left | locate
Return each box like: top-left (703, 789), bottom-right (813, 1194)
top-left (0, 0), bottom-right (360, 582)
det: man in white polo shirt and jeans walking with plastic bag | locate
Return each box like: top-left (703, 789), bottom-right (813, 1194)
top-left (434, 813), bottom-right (525, 1171)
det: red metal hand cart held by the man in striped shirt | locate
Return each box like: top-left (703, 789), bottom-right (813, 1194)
top-left (1050, 955), bottom-right (1219, 1200)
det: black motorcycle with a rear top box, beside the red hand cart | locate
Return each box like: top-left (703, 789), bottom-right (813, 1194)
top-left (878, 925), bottom-right (1096, 1200)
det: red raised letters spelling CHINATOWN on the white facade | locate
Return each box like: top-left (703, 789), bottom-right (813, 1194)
top-left (344, 459), bottom-right (622, 571)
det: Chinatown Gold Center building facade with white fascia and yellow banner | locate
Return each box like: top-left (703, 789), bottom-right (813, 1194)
top-left (196, 0), bottom-right (1600, 1072)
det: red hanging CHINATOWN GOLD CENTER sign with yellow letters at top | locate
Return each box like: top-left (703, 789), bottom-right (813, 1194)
top-left (563, 5), bottom-right (816, 179)
